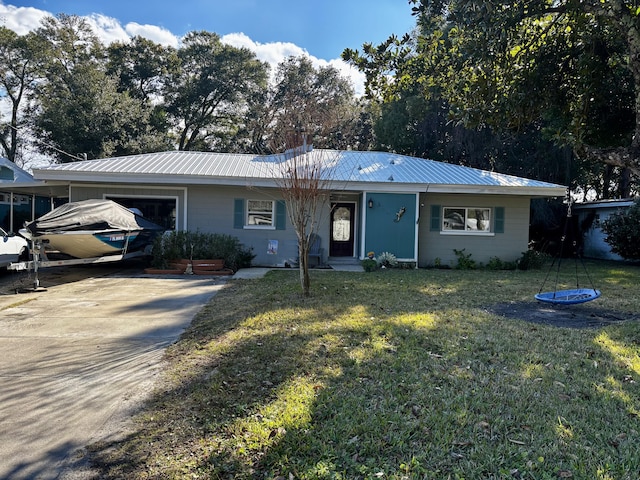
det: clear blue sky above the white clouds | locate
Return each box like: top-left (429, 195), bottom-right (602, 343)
top-left (5, 0), bottom-right (414, 60)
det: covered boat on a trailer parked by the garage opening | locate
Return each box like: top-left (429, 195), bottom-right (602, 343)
top-left (20, 200), bottom-right (165, 258)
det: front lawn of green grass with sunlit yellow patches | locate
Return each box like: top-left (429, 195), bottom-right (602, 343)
top-left (92, 262), bottom-right (640, 479)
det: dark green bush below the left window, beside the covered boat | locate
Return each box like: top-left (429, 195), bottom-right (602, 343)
top-left (151, 231), bottom-right (255, 271)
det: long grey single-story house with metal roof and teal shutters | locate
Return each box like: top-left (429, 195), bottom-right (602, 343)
top-left (13, 148), bottom-right (566, 266)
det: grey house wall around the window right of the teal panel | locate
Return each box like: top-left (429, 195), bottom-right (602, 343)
top-left (418, 193), bottom-right (530, 267)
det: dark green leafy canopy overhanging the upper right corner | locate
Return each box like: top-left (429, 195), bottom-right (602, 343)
top-left (343, 0), bottom-right (640, 197)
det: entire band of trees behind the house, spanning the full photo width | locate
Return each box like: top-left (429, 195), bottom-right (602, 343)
top-left (5, 5), bottom-right (640, 199)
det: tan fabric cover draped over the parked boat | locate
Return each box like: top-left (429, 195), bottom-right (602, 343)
top-left (25, 200), bottom-right (165, 236)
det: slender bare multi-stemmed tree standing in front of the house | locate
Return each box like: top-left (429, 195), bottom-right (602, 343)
top-left (273, 129), bottom-right (337, 297)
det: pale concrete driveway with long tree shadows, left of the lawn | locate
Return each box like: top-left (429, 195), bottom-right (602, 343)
top-left (0, 265), bottom-right (229, 479)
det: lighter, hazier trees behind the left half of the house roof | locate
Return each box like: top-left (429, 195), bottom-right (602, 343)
top-left (0, 14), bottom-right (373, 167)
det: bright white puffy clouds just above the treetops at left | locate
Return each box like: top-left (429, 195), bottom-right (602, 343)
top-left (0, 0), bottom-right (364, 95)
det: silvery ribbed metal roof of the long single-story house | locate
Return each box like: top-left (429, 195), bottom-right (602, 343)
top-left (34, 149), bottom-right (566, 196)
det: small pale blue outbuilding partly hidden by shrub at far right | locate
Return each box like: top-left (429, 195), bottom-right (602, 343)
top-left (573, 199), bottom-right (633, 260)
